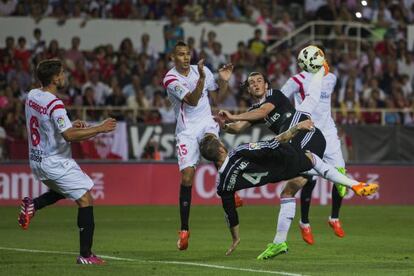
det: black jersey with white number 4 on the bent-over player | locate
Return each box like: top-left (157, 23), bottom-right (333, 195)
top-left (217, 139), bottom-right (312, 195)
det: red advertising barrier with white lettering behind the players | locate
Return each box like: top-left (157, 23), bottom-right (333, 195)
top-left (0, 163), bottom-right (414, 206)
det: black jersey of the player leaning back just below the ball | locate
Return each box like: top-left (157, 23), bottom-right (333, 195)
top-left (249, 89), bottom-right (309, 134)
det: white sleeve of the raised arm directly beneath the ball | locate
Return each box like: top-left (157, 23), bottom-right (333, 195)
top-left (296, 70), bottom-right (325, 115)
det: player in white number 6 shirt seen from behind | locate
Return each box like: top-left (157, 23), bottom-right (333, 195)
top-left (18, 59), bottom-right (116, 264)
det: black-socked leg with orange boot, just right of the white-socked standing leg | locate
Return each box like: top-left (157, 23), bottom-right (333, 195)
top-left (299, 176), bottom-right (316, 245)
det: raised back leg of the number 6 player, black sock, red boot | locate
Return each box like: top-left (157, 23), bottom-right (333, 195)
top-left (18, 190), bottom-right (65, 230)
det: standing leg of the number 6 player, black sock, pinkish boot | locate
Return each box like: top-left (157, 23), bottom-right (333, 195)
top-left (76, 191), bottom-right (105, 265)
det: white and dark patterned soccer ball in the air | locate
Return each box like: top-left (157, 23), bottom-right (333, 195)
top-left (298, 45), bottom-right (325, 73)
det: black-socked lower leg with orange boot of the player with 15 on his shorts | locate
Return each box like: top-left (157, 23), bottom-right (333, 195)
top-left (177, 167), bottom-right (195, 250)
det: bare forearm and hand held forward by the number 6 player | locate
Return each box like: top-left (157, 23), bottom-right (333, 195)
top-left (62, 118), bottom-right (116, 142)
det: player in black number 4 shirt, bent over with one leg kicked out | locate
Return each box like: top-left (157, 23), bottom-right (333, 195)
top-left (200, 120), bottom-right (378, 259)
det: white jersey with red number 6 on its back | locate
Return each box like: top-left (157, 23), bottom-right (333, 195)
top-left (25, 89), bottom-right (72, 168)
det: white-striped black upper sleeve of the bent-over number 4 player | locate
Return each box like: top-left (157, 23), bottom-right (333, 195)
top-left (233, 139), bottom-right (279, 163)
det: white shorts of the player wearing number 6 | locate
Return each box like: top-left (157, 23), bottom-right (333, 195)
top-left (30, 157), bottom-right (93, 200)
